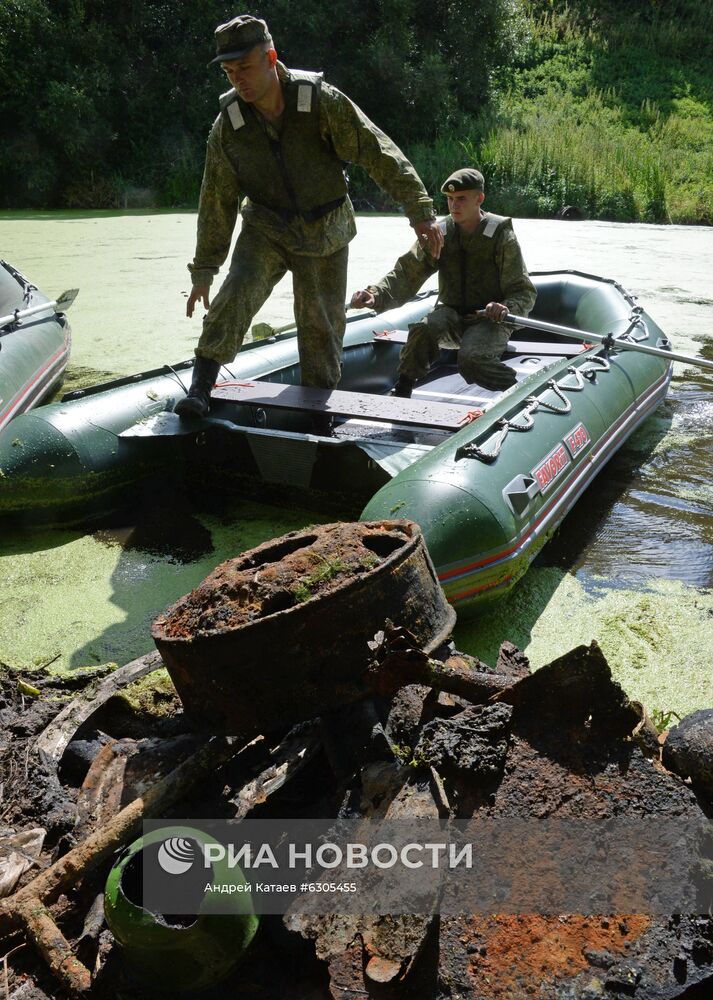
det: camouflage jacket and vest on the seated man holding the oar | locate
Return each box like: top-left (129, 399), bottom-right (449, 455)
top-left (368, 212), bottom-right (537, 316)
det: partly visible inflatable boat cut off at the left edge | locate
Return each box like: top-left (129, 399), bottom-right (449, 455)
top-left (0, 260), bottom-right (71, 429)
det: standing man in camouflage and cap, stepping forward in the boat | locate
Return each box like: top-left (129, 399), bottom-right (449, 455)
top-left (176, 15), bottom-right (443, 432)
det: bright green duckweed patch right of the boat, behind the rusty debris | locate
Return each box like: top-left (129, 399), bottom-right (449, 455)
top-left (455, 567), bottom-right (713, 716)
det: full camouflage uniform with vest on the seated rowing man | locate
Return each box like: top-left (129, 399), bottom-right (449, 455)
top-left (369, 212), bottom-right (537, 390)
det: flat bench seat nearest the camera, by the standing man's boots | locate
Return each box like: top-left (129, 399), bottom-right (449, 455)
top-left (212, 381), bottom-right (480, 431)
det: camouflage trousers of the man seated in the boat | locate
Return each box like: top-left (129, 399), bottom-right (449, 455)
top-left (399, 306), bottom-right (516, 391)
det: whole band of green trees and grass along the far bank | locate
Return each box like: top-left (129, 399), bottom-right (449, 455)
top-left (0, 0), bottom-right (713, 224)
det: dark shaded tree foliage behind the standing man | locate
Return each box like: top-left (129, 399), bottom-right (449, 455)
top-left (0, 0), bottom-right (522, 207)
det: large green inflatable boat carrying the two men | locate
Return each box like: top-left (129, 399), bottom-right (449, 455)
top-left (0, 271), bottom-right (673, 609)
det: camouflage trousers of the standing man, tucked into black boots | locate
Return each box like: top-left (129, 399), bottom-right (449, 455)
top-left (196, 225), bottom-right (349, 389)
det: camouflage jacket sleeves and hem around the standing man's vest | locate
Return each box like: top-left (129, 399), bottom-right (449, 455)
top-left (188, 63), bottom-right (433, 285)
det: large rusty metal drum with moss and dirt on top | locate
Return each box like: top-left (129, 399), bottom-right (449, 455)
top-left (152, 520), bottom-right (455, 738)
